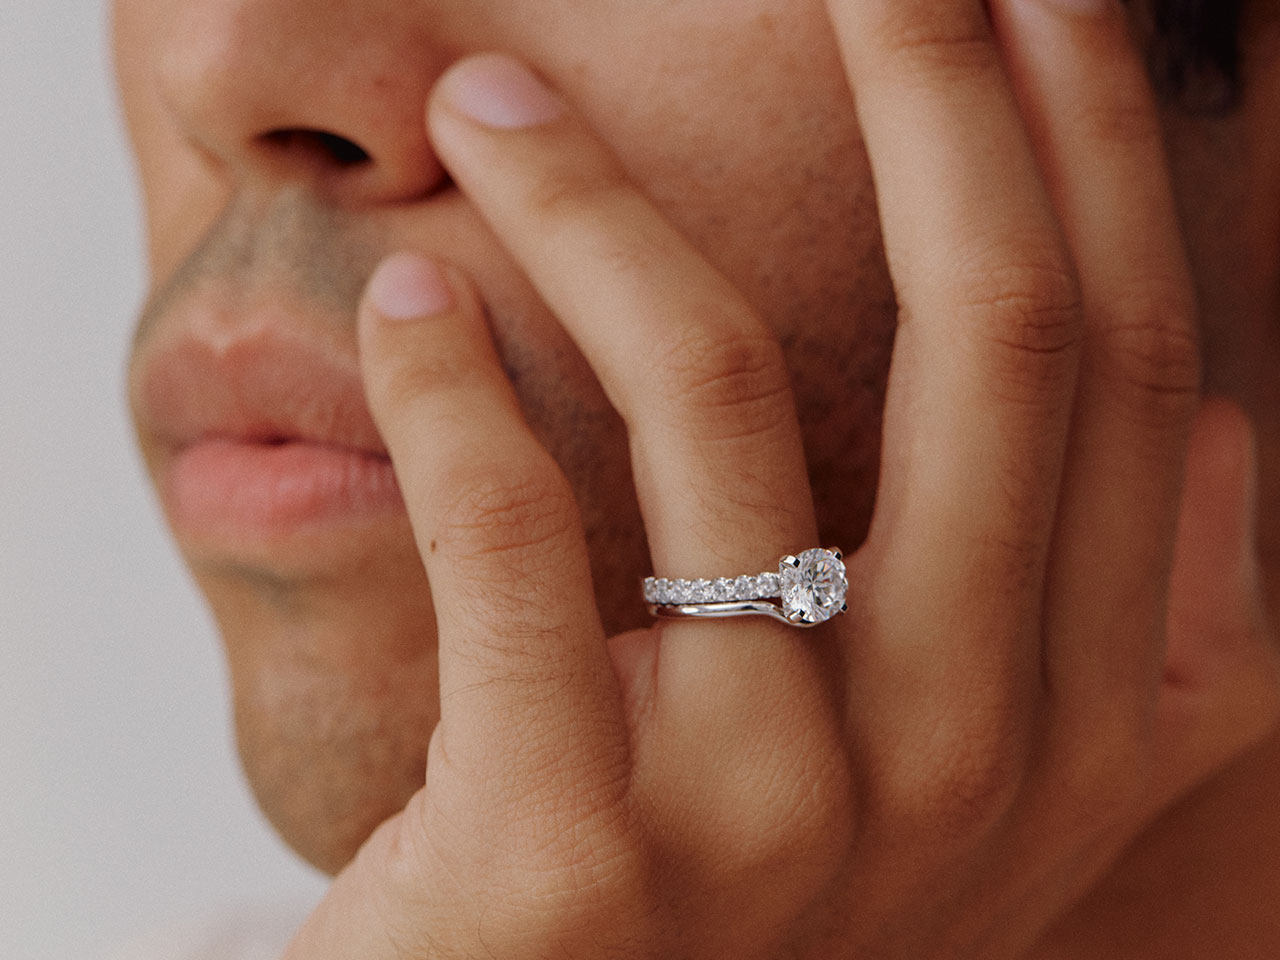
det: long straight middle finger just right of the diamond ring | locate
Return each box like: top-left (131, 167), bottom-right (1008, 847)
top-left (828, 0), bottom-right (1083, 742)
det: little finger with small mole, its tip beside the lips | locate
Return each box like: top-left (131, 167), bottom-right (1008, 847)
top-left (360, 255), bottom-right (627, 804)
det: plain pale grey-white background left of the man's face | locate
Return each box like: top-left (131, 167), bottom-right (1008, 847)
top-left (0, 0), bottom-right (323, 960)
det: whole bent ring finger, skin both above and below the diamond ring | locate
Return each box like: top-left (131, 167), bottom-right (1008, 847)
top-left (429, 55), bottom-right (827, 829)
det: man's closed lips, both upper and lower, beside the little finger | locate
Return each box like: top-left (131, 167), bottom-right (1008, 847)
top-left (133, 326), bottom-right (404, 554)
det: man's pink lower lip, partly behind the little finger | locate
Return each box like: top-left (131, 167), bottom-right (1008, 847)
top-left (166, 439), bottom-right (404, 539)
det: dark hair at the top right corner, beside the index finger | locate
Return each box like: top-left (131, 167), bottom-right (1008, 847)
top-left (1151, 0), bottom-right (1244, 110)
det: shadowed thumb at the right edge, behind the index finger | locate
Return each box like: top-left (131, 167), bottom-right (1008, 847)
top-left (1156, 399), bottom-right (1280, 805)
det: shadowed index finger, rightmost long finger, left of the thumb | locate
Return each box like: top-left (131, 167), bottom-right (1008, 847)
top-left (993, 0), bottom-right (1199, 753)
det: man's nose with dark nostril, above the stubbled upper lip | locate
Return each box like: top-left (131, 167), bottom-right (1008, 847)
top-left (156, 0), bottom-right (447, 206)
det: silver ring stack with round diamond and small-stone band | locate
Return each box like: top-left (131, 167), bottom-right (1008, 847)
top-left (644, 549), bottom-right (849, 627)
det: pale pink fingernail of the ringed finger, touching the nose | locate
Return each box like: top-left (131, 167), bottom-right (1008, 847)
top-left (443, 54), bottom-right (564, 131)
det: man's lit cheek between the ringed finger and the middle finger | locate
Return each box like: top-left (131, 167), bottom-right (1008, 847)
top-left (542, 0), bottom-right (879, 335)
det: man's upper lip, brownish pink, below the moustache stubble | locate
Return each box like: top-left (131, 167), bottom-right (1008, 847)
top-left (132, 328), bottom-right (387, 457)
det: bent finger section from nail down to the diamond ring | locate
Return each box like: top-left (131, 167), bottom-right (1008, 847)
top-left (429, 55), bottom-right (817, 586)
